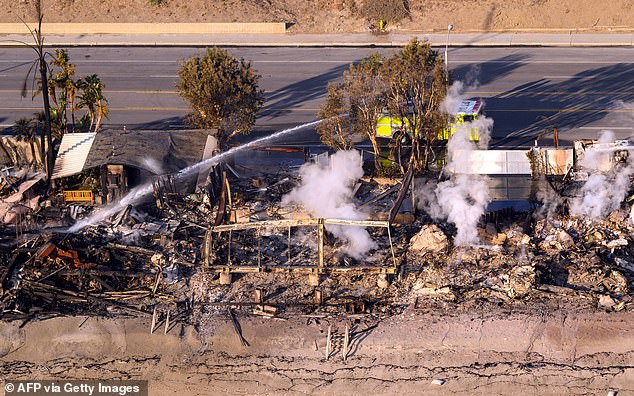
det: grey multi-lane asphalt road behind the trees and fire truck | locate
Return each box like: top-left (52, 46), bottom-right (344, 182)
top-left (0, 47), bottom-right (634, 147)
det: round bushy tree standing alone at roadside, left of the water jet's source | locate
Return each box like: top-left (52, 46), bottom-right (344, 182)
top-left (176, 48), bottom-right (264, 146)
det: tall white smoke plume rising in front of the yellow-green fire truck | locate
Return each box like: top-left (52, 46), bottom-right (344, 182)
top-left (417, 77), bottom-right (493, 246)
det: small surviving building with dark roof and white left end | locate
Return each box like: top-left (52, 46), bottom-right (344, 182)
top-left (53, 129), bottom-right (217, 203)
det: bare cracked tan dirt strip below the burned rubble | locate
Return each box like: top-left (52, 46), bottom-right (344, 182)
top-left (0, 311), bottom-right (634, 395)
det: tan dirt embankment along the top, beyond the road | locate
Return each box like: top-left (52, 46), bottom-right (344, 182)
top-left (0, 0), bottom-right (634, 33)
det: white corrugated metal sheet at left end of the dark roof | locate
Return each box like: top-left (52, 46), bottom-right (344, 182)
top-left (53, 132), bottom-right (96, 179)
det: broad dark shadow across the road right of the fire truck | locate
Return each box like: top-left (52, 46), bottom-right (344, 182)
top-left (487, 63), bottom-right (634, 145)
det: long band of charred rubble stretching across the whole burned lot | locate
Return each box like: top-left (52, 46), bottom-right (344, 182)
top-left (0, 155), bottom-right (634, 323)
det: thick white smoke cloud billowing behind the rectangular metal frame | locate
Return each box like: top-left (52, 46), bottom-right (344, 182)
top-left (282, 150), bottom-right (376, 259)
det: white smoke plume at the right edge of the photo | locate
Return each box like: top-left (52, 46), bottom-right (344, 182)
top-left (570, 131), bottom-right (634, 219)
